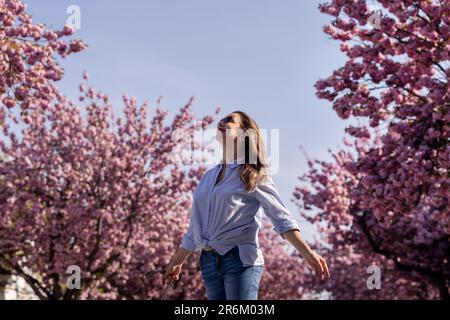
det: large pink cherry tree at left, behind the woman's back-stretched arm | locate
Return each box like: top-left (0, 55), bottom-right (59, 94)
top-left (0, 71), bottom-right (219, 299)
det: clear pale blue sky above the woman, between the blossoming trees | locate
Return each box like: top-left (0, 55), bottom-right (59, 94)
top-left (24, 0), bottom-right (345, 238)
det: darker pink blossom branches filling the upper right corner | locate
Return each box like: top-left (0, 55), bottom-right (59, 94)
top-left (316, 1), bottom-right (450, 232)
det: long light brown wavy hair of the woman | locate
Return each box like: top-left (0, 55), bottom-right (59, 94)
top-left (232, 111), bottom-right (268, 191)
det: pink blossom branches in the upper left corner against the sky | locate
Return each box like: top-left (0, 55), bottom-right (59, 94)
top-left (0, 0), bottom-right (86, 114)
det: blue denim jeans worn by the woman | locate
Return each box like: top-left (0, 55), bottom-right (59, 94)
top-left (199, 246), bottom-right (264, 300)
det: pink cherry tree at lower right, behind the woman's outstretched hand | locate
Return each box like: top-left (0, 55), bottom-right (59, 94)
top-left (294, 139), bottom-right (444, 299)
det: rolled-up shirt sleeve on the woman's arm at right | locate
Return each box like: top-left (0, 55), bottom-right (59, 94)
top-left (254, 176), bottom-right (300, 239)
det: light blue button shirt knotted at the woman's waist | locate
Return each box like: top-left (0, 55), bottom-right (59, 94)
top-left (181, 160), bottom-right (300, 266)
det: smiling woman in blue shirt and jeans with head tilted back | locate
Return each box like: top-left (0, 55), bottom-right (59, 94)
top-left (164, 111), bottom-right (330, 300)
